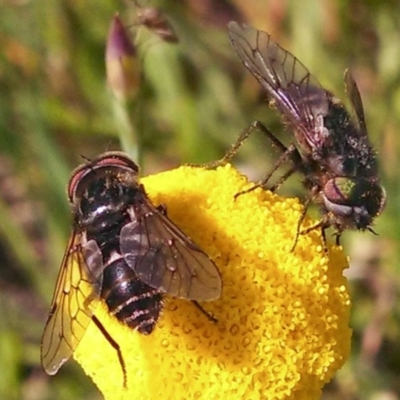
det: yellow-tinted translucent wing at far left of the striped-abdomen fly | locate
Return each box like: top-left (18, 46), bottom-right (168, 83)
top-left (41, 233), bottom-right (101, 375)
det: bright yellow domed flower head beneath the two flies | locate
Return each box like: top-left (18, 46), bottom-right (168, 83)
top-left (74, 165), bottom-right (351, 400)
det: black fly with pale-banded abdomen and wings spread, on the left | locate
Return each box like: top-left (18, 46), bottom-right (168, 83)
top-left (41, 152), bottom-right (222, 375)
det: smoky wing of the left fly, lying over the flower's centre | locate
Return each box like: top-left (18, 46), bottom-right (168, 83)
top-left (120, 201), bottom-right (222, 301)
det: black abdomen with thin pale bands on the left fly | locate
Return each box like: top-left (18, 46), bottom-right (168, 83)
top-left (101, 257), bottom-right (162, 334)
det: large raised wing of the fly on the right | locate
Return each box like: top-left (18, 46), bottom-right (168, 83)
top-left (228, 21), bottom-right (330, 141)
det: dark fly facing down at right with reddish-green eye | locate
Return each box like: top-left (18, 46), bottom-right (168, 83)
top-left (223, 22), bottom-right (386, 244)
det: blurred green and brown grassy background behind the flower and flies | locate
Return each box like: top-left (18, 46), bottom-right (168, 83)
top-left (0, 0), bottom-right (400, 400)
